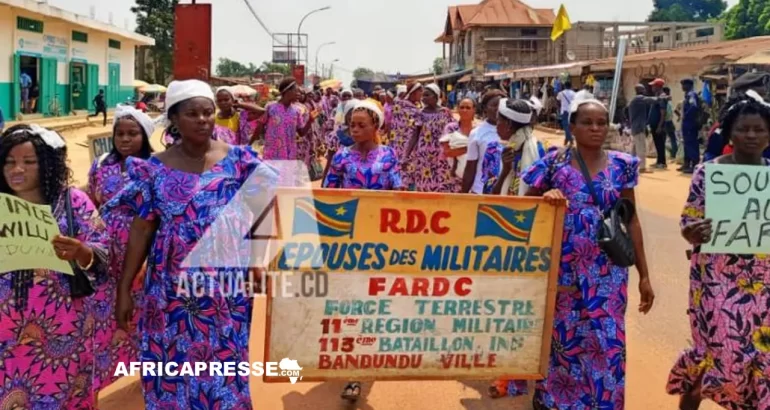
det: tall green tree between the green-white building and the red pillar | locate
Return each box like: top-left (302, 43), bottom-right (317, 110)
top-left (131, 0), bottom-right (179, 83)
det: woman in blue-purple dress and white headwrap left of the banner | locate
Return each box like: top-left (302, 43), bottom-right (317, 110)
top-left (105, 80), bottom-right (275, 410)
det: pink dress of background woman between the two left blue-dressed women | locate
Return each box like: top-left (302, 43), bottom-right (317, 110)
top-left (262, 103), bottom-right (307, 160)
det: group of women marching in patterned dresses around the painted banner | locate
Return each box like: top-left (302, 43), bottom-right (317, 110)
top-left (0, 73), bottom-right (770, 410)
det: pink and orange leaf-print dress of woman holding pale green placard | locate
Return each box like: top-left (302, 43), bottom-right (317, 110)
top-left (666, 159), bottom-right (770, 410)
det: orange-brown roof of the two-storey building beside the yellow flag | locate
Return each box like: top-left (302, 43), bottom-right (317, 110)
top-left (463, 0), bottom-right (556, 26)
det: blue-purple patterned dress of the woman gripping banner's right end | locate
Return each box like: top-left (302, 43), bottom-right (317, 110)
top-left (509, 151), bottom-right (639, 410)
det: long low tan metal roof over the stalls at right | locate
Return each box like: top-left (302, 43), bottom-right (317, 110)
top-left (591, 36), bottom-right (770, 70)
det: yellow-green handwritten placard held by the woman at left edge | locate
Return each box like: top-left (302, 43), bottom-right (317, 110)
top-left (0, 193), bottom-right (73, 275)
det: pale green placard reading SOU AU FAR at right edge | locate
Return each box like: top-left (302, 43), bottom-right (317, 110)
top-left (701, 164), bottom-right (770, 255)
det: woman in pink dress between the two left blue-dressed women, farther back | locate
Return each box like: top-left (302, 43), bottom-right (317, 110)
top-left (252, 78), bottom-right (313, 160)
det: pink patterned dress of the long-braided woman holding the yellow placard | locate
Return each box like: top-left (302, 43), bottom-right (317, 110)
top-left (0, 188), bottom-right (108, 410)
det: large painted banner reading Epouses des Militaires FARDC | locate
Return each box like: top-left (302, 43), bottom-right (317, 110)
top-left (265, 190), bottom-right (564, 382)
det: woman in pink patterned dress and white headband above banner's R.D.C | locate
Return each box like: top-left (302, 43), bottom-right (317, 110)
top-left (402, 84), bottom-right (460, 193)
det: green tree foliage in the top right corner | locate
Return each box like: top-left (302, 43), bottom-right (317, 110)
top-left (723, 0), bottom-right (770, 40)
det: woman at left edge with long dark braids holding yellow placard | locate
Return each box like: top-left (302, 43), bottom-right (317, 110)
top-left (0, 125), bottom-right (109, 410)
